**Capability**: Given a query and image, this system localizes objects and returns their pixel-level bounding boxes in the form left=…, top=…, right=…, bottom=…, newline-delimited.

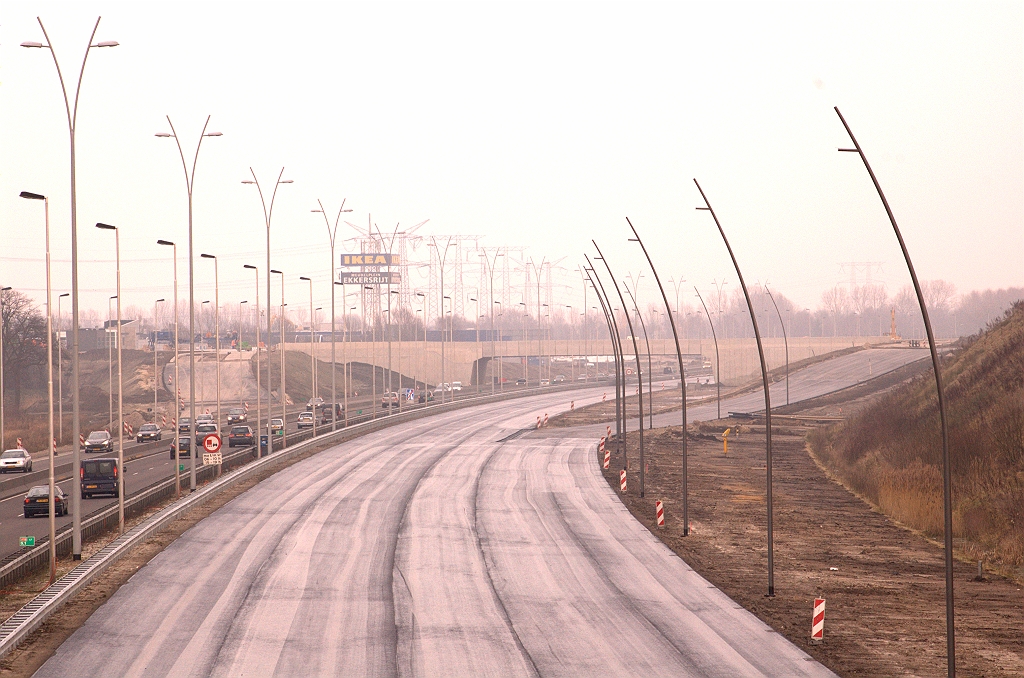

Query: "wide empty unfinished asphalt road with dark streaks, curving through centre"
left=36, top=389, right=833, bottom=676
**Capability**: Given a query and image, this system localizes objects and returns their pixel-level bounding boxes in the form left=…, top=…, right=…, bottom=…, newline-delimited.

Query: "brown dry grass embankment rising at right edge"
left=809, top=301, right=1024, bottom=581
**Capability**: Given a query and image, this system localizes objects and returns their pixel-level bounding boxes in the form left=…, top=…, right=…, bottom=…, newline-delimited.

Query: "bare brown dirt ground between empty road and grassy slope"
left=604, top=421, right=1024, bottom=676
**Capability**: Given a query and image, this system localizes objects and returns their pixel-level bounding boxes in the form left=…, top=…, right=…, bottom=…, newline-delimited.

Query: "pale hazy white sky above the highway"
left=0, top=1, right=1024, bottom=323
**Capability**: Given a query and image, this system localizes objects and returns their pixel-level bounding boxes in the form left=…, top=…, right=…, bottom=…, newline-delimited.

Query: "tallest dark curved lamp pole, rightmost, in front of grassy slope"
left=836, top=108, right=956, bottom=678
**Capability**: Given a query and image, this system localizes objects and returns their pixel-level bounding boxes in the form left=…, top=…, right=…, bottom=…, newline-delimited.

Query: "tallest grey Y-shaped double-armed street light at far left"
left=21, top=16, right=118, bottom=560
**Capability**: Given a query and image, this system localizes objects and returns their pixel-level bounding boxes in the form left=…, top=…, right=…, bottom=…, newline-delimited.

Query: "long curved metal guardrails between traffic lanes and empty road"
left=0, top=384, right=593, bottom=658
